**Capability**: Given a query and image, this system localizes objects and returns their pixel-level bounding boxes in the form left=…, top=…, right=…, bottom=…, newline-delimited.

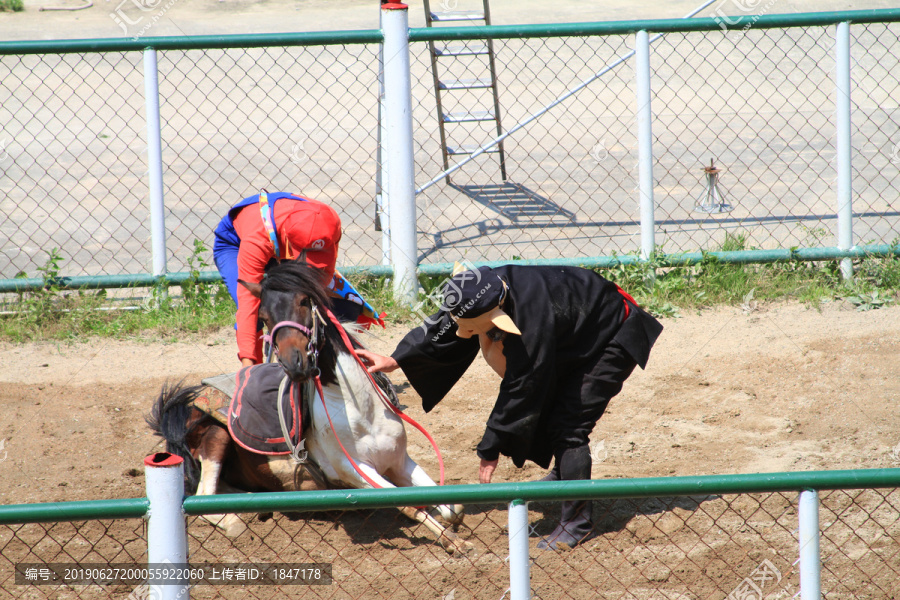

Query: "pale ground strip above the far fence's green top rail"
left=0, top=0, right=895, bottom=40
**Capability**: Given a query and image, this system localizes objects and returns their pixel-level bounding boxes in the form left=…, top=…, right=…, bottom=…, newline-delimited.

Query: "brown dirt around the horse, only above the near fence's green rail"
left=0, top=301, right=900, bottom=504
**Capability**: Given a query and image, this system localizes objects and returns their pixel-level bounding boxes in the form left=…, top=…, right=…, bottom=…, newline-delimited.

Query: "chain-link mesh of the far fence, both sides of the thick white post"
left=0, top=11, right=900, bottom=290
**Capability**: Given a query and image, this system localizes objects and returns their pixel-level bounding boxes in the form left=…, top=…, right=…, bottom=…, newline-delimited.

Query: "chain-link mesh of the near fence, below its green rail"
left=0, top=489, right=900, bottom=600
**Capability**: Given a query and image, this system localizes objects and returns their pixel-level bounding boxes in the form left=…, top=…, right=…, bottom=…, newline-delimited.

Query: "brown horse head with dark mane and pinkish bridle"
left=240, top=261, right=334, bottom=382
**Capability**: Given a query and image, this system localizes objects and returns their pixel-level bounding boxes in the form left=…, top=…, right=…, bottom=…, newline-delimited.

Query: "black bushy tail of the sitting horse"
left=145, top=381, right=204, bottom=495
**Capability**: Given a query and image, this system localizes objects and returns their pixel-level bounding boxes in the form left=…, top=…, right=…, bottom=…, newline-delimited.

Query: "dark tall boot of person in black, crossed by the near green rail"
left=538, top=446, right=594, bottom=550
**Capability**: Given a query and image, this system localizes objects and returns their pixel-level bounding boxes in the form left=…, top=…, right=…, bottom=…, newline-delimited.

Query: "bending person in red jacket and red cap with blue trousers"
left=213, top=190, right=384, bottom=366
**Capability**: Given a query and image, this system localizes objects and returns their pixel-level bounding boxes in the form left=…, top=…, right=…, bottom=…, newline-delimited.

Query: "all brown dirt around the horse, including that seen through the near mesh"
left=0, top=301, right=900, bottom=600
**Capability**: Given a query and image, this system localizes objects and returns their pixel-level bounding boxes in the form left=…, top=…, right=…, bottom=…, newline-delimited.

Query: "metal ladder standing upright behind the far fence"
left=424, top=0, right=506, bottom=184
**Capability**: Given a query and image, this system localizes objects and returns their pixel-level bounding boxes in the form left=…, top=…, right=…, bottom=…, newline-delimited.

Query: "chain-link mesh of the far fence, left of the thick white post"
left=0, top=45, right=380, bottom=278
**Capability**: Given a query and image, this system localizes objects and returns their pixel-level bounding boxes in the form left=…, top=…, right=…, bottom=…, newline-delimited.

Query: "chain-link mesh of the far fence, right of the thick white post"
left=414, top=19, right=900, bottom=261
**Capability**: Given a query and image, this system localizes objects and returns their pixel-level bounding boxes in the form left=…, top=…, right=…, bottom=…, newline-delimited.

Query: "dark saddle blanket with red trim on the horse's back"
left=200, top=363, right=309, bottom=456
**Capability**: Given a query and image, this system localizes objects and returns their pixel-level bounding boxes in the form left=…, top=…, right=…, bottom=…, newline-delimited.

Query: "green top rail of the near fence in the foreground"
left=0, top=469, right=900, bottom=525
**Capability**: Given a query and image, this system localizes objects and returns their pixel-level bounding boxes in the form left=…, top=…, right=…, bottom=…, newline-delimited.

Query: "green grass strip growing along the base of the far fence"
left=0, top=233, right=900, bottom=342
